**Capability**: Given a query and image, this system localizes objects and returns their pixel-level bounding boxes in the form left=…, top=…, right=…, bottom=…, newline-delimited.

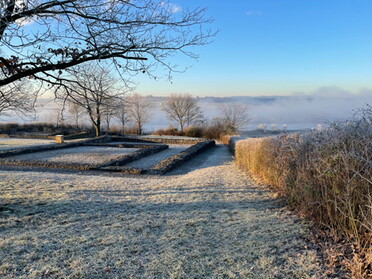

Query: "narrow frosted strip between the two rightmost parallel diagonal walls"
left=125, top=144, right=192, bottom=169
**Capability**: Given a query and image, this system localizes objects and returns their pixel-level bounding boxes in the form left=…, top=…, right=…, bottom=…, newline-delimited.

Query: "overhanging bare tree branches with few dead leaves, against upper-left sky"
left=0, top=0, right=214, bottom=91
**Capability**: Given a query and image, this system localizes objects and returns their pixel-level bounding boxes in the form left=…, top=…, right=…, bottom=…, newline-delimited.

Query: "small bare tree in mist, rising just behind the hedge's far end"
left=220, top=103, right=250, bottom=134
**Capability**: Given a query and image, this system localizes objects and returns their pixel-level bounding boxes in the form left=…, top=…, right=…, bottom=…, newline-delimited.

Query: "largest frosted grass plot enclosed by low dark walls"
left=7, top=146, right=138, bottom=164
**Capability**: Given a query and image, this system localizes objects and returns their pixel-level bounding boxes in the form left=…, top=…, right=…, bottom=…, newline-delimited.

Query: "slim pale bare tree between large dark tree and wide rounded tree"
left=128, top=93, right=151, bottom=134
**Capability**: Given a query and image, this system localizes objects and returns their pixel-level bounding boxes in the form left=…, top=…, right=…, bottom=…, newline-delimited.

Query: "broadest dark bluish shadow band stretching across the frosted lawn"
left=0, top=198, right=284, bottom=224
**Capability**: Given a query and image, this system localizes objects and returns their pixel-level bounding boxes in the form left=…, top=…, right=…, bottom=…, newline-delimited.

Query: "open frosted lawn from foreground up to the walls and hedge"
left=0, top=146, right=332, bottom=278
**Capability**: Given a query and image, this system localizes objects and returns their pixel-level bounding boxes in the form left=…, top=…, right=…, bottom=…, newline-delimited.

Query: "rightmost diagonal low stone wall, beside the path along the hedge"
left=149, top=140, right=216, bottom=174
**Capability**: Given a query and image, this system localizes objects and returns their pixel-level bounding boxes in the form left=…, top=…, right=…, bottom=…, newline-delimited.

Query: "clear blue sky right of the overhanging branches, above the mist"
left=135, top=0, right=372, bottom=96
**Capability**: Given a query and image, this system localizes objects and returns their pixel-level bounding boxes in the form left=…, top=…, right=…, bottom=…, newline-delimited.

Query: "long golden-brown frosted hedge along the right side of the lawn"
left=235, top=106, right=372, bottom=278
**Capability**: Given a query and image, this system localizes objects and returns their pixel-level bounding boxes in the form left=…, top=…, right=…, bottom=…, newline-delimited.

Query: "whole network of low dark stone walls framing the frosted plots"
left=0, top=136, right=215, bottom=175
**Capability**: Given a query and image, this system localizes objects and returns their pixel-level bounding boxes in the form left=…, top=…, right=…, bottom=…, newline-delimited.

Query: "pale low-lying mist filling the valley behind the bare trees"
left=0, top=87, right=372, bottom=131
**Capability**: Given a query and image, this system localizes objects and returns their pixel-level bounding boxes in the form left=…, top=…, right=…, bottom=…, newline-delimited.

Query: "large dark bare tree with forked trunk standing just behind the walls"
left=64, top=64, right=123, bottom=137
